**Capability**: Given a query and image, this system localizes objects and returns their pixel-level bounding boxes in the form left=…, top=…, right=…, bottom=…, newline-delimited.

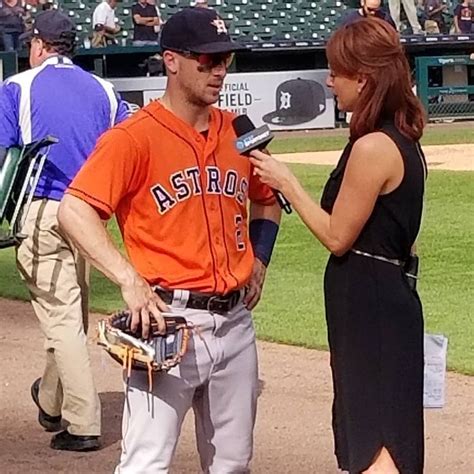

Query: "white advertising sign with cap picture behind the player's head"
left=110, top=70, right=335, bottom=130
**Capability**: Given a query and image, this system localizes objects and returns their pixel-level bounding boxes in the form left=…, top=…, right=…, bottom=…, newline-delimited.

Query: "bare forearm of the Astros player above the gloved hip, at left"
left=58, top=194, right=137, bottom=286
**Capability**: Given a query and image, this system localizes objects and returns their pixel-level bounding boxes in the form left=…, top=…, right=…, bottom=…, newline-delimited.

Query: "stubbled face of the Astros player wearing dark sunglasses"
left=177, top=53, right=233, bottom=106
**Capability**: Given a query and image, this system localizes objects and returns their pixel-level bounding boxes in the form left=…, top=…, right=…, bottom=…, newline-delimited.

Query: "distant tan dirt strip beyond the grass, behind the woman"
left=275, top=145, right=474, bottom=171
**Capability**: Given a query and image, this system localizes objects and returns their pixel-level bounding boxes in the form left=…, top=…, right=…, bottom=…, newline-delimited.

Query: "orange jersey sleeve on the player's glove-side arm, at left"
left=66, top=128, right=146, bottom=219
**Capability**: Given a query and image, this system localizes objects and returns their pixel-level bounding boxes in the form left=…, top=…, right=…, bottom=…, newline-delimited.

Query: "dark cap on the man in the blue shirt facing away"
left=20, top=10, right=76, bottom=41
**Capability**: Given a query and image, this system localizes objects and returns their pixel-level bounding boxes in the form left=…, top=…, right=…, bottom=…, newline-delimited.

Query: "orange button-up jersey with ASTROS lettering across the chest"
left=67, top=102, right=275, bottom=294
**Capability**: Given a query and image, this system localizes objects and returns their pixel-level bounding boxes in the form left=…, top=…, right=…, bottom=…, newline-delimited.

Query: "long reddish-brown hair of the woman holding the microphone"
left=326, top=18, right=425, bottom=140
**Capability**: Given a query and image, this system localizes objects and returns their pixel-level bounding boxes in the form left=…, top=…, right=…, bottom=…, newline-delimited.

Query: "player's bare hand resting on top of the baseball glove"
left=120, top=275, right=169, bottom=339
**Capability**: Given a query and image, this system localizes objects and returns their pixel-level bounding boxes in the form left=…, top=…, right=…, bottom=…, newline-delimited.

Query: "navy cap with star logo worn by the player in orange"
left=160, top=8, right=247, bottom=54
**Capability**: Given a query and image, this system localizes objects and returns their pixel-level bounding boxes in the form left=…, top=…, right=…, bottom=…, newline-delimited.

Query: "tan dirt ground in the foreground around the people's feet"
left=0, top=299, right=474, bottom=474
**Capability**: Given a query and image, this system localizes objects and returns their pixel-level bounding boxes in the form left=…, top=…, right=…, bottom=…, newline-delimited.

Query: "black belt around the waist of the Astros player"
left=154, top=288, right=243, bottom=314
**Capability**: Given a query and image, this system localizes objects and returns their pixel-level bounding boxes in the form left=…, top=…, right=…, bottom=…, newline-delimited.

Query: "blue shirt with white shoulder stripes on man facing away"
left=0, top=51, right=128, bottom=201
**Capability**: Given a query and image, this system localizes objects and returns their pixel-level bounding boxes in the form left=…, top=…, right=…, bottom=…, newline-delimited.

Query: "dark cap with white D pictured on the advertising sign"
left=262, top=78, right=326, bottom=125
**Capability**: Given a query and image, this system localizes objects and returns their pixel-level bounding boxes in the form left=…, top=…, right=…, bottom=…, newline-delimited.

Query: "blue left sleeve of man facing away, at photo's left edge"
left=0, top=82, right=22, bottom=148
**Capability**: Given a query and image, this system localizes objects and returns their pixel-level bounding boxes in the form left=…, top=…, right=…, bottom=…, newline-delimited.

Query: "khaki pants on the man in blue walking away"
left=17, top=199, right=100, bottom=436
